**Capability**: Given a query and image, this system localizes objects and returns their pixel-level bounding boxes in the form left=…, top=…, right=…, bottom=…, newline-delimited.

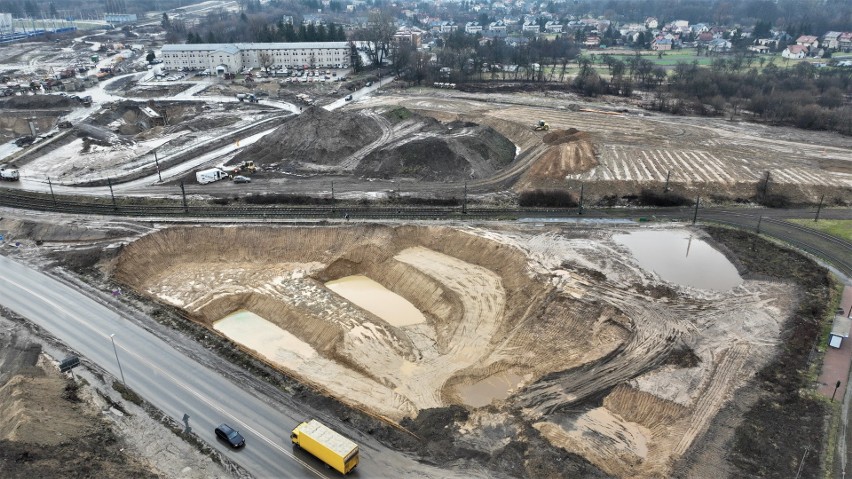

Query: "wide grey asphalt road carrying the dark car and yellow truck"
left=0, top=256, right=470, bottom=478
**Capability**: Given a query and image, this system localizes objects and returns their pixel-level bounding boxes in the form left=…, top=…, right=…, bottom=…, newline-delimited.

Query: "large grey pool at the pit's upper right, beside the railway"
left=613, top=230, right=743, bottom=291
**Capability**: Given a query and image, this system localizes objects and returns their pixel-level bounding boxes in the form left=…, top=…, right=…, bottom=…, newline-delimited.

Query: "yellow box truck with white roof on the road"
left=290, top=419, right=358, bottom=474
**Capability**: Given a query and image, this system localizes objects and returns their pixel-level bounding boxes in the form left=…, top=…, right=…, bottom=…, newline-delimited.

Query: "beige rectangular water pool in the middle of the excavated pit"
left=325, top=274, right=426, bottom=326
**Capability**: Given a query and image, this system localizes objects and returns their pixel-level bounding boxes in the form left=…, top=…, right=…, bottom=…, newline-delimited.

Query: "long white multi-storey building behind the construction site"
left=161, top=42, right=351, bottom=73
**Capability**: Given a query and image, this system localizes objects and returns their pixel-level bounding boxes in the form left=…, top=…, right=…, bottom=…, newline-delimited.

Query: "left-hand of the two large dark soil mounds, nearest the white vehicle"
left=235, top=107, right=381, bottom=170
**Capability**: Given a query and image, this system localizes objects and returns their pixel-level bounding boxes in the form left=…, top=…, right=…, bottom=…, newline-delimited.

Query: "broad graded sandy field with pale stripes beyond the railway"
left=359, top=89, right=852, bottom=202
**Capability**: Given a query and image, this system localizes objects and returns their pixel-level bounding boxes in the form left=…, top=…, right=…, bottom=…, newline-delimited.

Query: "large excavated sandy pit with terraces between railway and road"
left=113, top=225, right=793, bottom=477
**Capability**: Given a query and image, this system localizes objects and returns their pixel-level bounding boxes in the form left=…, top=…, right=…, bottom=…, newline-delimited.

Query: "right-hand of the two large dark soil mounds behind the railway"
left=355, top=119, right=515, bottom=181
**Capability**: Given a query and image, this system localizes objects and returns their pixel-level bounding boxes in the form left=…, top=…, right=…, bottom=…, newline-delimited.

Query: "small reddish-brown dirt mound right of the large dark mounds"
left=515, top=128, right=598, bottom=190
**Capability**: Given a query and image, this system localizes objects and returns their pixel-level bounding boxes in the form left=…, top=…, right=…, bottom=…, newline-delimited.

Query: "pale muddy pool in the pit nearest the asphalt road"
left=213, top=311, right=317, bottom=364
